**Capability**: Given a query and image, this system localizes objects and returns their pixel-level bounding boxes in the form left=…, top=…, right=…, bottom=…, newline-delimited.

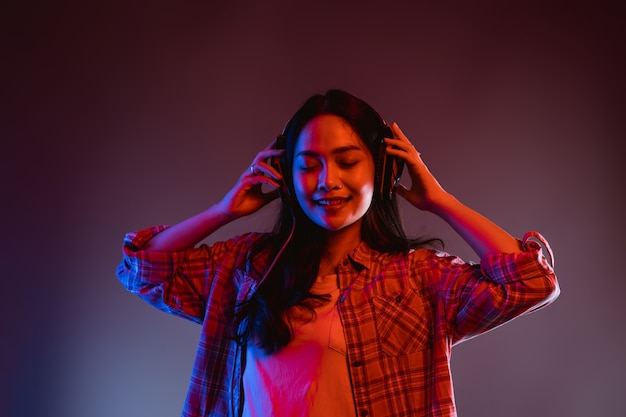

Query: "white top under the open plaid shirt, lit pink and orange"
left=243, top=275, right=356, bottom=417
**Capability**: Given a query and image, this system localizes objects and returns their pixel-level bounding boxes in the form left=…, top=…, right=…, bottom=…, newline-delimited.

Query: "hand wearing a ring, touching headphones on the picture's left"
left=217, top=143, right=285, bottom=220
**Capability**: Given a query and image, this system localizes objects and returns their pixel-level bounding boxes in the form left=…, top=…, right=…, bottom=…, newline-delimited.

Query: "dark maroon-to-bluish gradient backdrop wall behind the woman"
left=0, top=1, right=626, bottom=417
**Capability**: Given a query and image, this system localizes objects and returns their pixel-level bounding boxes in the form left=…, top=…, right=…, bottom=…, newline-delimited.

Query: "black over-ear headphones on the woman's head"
left=272, top=118, right=404, bottom=203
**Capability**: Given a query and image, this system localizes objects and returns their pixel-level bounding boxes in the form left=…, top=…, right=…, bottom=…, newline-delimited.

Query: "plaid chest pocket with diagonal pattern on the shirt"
left=373, top=288, right=432, bottom=356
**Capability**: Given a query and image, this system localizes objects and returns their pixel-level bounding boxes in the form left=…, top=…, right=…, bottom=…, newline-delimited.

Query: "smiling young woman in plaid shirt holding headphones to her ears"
left=117, top=90, right=559, bottom=417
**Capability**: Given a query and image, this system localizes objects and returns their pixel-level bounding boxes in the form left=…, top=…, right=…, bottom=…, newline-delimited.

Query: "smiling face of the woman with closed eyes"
left=293, top=114, right=375, bottom=231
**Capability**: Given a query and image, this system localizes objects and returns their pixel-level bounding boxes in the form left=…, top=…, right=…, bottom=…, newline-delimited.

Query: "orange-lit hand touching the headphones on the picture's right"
left=385, top=123, right=449, bottom=211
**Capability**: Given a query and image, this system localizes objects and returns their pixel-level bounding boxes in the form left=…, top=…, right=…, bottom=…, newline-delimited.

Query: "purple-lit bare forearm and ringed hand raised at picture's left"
left=143, top=145, right=283, bottom=252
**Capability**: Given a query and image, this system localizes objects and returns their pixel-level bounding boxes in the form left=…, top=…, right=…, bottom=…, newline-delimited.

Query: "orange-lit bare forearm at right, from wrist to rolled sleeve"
left=430, top=193, right=522, bottom=257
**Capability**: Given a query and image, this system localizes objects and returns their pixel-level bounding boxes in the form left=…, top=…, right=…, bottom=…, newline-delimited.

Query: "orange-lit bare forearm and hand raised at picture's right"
left=386, top=123, right=522, bottom=257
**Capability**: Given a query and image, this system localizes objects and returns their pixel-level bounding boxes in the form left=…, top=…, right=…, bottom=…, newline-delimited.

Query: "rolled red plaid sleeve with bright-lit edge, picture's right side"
left=432, top=232, right=560, bottom=343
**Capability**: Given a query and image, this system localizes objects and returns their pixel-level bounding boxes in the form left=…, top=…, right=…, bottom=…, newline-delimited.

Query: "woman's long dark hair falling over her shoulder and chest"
left=234, top=90, right=443, bottom=354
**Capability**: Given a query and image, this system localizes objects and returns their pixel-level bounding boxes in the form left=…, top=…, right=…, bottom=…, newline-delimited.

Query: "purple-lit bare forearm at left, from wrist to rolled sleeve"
left=143, top=205, right=234, bottom=252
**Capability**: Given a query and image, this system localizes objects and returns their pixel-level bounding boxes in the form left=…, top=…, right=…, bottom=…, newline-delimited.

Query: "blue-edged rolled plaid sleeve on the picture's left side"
left=116, top=226, right=256, bottom=323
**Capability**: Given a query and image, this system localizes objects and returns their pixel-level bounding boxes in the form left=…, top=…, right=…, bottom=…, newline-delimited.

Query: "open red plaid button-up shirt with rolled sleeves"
left=117, top=226, right=559, bottom=417
